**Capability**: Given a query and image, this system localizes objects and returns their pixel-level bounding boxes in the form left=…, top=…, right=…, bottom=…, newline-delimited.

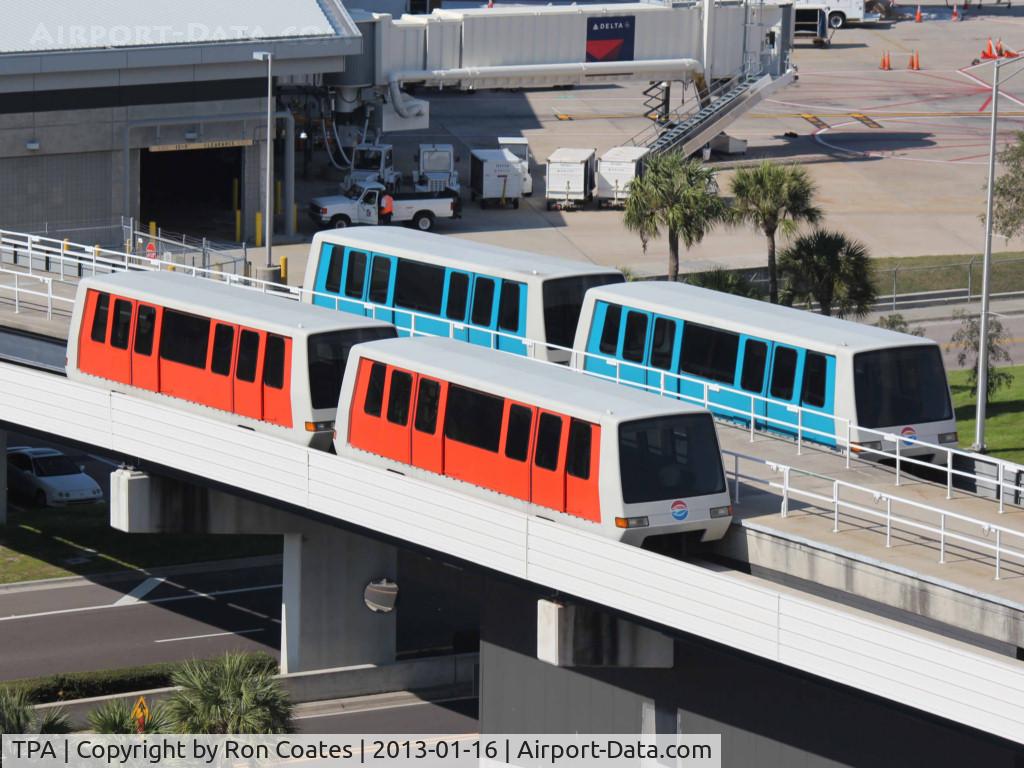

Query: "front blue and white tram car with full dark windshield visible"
left=572, top=282, right=957, bottom=460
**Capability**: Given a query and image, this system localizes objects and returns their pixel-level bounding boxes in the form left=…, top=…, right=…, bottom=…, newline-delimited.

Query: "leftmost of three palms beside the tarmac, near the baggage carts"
left=625, top=153, right=728, bottom=281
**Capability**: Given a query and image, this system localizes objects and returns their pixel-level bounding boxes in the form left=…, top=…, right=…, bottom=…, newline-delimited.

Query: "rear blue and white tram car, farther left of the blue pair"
left=303, top=226, right=624, bottom=362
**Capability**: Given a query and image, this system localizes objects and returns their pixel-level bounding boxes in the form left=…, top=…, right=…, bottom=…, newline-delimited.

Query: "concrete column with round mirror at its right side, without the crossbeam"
left=281, top=526, right=400, bottom=673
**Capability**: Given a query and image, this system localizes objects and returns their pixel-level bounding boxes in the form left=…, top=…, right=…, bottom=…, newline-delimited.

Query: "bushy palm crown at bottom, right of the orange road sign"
left=166, top=653, right=292, bottom=733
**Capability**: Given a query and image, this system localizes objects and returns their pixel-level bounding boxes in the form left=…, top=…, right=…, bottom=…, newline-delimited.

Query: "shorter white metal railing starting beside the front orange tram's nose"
left=722, top=450, right=1024, bottom=581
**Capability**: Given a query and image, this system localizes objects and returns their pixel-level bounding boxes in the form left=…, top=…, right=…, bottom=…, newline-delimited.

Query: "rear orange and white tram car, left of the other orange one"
left=68, top=271, right=395, bottom=450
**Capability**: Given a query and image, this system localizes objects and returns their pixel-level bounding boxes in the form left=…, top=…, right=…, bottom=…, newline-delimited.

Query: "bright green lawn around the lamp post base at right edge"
left=949, top=366, right=1024, bottom=464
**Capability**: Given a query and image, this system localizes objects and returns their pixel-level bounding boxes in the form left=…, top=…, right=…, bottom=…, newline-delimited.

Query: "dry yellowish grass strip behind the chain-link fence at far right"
left=871, top=252, right=1024, bottom=296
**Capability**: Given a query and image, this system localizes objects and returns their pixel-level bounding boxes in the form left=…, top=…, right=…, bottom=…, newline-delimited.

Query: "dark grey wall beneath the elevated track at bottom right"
left=480, top=579, right=1021, bottom=768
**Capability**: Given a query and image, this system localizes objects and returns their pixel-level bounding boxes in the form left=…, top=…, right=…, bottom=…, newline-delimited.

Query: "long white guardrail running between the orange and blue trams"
left=0, top=229, right=1024, bottom=513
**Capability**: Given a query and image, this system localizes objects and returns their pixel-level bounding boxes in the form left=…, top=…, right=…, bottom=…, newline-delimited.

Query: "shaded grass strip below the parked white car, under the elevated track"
left=0, top=504, right=281, bottom=584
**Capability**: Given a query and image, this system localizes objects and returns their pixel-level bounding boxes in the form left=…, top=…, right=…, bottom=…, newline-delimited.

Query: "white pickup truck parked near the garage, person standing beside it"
left=309, top=182, right=462, bottom=232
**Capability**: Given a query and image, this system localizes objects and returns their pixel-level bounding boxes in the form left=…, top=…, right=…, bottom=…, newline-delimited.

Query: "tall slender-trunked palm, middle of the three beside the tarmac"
left=732, top=160, right=821, bottom=304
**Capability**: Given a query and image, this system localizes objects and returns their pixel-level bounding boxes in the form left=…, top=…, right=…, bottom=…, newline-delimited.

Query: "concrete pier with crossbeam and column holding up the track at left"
left=111, top=469, right=398, bottom=673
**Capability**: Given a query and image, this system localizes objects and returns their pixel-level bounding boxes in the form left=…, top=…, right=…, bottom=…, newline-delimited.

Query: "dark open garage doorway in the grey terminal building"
left=139, top=146, right=244, bottom=241
